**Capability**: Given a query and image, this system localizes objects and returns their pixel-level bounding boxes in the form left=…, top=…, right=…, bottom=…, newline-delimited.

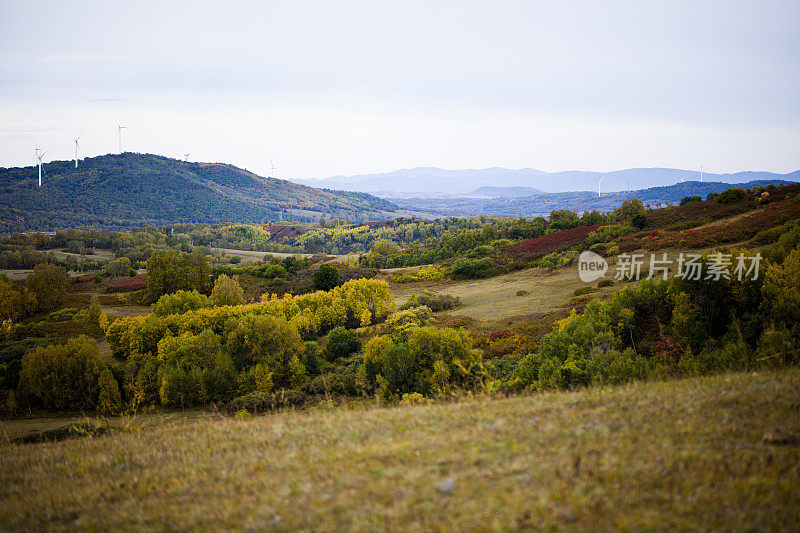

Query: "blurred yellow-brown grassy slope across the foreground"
left=0, top=370, right=800, bottom=531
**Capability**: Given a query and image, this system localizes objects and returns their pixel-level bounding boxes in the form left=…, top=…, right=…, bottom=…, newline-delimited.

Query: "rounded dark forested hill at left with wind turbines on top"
left=0, top=153, right=396, bottom=232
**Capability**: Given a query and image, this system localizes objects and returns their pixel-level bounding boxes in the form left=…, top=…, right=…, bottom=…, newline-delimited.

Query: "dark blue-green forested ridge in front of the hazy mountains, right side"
left=395, top=180, right=792, bottom=217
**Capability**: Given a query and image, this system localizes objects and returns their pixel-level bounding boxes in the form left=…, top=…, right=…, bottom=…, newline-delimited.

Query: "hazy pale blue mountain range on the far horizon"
left=294, top=167, right=800, bottom=198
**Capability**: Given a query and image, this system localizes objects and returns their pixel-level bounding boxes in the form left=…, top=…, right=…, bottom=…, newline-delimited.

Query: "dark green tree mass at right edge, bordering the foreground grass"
left=506, top=230, right=800, bottom=390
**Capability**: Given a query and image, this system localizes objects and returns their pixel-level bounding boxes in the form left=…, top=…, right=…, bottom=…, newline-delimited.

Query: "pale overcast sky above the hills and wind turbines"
left=0, top=0, right=800, bottom=178
